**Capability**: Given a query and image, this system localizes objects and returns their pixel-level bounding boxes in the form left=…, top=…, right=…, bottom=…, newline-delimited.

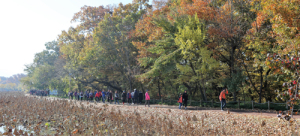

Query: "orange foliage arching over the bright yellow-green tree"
left=133, top=0, right=250, bottom=63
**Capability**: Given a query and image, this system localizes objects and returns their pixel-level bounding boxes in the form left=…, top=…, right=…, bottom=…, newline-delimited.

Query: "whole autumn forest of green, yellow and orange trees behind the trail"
left=21, top=0, right=300, bottom=102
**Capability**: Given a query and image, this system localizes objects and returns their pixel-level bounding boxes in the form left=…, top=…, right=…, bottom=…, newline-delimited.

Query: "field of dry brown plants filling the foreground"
left=0, top=93, right=299, bottom=136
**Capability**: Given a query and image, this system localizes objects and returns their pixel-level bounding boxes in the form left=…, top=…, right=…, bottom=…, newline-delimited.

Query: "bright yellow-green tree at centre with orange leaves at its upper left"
left=134, top=0, right=218, bottom=100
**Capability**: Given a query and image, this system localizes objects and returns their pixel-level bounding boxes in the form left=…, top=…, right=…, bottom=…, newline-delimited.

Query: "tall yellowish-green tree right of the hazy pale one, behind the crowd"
left=68, top=1, right=149, bottom=91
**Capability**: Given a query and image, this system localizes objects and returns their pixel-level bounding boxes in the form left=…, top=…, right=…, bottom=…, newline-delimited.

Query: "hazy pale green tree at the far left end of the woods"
left=21, top=41, right=66, bottom=91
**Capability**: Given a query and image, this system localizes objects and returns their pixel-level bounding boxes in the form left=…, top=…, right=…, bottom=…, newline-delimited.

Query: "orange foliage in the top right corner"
left=262, top=0, right=300, bottom=53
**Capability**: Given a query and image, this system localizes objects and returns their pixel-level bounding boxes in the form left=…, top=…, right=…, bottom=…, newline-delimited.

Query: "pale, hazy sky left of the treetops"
left=0, top=0, right=136, bottom=77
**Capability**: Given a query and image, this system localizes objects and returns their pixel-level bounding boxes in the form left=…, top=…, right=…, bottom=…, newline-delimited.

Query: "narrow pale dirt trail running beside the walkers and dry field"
left=26, top=94, right=300, bottom=119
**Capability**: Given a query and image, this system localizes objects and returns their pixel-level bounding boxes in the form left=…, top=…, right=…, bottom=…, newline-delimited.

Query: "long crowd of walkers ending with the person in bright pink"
left=68, top=89, right=150, bottom=107
